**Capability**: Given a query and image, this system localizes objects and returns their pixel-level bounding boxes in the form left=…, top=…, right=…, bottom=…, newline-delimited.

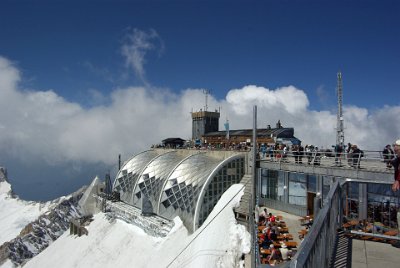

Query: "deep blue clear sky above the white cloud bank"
left=0, top=1, right=400, bottom=109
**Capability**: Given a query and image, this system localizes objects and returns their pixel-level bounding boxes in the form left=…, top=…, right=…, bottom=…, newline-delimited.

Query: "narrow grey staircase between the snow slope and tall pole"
left=234, top=174, right=253, bottom=226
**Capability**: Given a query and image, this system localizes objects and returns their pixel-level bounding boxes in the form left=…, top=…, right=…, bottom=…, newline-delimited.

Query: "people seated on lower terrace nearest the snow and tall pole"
left=258, top=208, right=290, bottom=265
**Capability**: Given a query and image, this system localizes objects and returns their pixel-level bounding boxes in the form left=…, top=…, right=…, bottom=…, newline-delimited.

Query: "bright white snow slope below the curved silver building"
left=24, top=184, right=250, bottom=268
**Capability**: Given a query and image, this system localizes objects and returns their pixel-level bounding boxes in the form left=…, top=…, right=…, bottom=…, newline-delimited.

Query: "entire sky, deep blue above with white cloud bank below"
left=0, top=0, right=400, bottom=199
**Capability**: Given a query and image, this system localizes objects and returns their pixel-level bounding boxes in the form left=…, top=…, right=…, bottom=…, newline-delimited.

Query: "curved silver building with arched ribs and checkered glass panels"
left=113, top=150, right=245, bottom=232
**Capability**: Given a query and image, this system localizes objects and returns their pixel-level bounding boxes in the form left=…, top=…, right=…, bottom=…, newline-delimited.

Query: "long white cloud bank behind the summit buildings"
left=0, top=56, right=400, bottom=200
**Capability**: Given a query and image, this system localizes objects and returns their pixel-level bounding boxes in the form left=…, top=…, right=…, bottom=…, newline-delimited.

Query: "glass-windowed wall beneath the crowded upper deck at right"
left=259, top=168, right=400, bottom=230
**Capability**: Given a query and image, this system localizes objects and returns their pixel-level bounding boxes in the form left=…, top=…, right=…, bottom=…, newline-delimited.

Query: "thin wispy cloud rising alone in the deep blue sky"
left=121, top=29, right=164, bottom=85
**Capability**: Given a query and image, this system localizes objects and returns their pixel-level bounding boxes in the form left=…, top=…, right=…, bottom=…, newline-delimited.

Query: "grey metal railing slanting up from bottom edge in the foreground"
left=290, top=181, right=343, bottom=268
